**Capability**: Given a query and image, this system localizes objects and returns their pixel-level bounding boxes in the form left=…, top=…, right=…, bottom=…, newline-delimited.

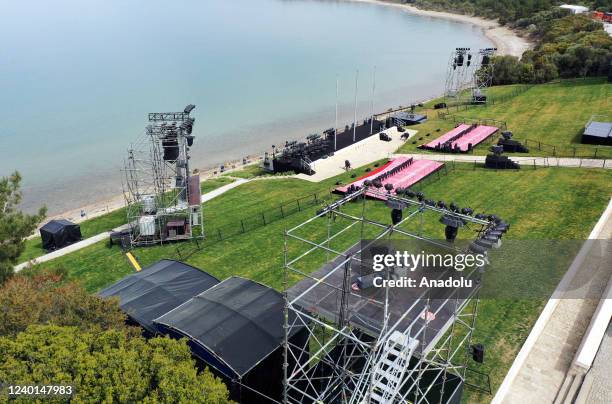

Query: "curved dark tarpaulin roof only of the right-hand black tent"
left=155, top=277, right=296, bottom=377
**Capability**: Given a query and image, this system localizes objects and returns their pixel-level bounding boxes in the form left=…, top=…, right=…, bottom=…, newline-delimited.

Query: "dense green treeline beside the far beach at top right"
left=412, top=0, right=612, bottom=84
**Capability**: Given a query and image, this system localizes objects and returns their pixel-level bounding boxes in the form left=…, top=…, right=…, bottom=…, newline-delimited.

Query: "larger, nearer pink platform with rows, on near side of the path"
left=336, top=157, right=444, bottom=200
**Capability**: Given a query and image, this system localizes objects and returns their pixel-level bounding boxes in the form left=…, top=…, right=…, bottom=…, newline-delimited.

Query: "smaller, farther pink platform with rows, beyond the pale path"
left=420, top=123, right=499, bottom=153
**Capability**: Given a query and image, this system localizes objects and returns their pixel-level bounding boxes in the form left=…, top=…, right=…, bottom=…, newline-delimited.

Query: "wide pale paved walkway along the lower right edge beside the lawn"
left=493, top=201, right=612, bottom=404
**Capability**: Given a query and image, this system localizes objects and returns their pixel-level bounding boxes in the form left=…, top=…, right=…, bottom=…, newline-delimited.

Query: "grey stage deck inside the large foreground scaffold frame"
left=287, top=244, right=468, bottom=355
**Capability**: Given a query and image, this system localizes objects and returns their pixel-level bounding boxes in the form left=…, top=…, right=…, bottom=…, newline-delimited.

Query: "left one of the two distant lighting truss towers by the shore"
left=444, top=48, right=475, bottom=107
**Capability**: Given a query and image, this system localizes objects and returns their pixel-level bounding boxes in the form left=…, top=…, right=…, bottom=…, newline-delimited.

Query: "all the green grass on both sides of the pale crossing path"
left=13, top=80, right=612, bottom=402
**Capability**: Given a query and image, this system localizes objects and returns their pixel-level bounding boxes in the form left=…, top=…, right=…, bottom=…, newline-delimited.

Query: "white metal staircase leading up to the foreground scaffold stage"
left=369, top=330, right=419, bottom=404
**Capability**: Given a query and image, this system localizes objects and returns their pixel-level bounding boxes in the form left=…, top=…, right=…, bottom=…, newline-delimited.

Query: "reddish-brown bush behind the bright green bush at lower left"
left=0, top=273, right=128, bottom=336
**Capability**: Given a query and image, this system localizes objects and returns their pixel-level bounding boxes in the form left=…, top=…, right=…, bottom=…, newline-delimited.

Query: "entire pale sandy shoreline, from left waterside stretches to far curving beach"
left=45, top=0, right=533, bottom=227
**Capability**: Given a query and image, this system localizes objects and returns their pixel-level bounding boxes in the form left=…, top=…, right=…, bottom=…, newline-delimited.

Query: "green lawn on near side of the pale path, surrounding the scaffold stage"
left=23, top=160, right=612, bottom=402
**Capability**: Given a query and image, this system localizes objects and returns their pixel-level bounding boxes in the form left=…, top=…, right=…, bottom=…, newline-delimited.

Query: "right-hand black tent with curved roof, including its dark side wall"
left=155, top=277, right=306, bottom=403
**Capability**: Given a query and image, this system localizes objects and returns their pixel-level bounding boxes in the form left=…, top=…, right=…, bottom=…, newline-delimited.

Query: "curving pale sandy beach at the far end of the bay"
left=350, top=0, right=533, bottom=57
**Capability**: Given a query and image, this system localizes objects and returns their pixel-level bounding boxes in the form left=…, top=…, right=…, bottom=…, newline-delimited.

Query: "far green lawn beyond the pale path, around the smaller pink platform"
left=400, top=78, right=612, bottom=158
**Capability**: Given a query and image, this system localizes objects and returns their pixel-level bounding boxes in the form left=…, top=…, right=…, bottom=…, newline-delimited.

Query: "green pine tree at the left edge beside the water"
left=0, top=172, right=46, bottom=284
